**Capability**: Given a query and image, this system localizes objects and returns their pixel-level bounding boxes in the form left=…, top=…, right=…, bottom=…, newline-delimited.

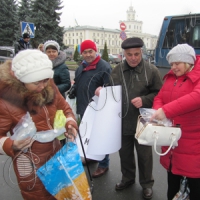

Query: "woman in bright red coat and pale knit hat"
left=152, top=44, right=200, bottom=200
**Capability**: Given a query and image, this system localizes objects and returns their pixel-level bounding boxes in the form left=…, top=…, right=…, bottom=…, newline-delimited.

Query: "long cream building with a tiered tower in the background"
left=63, top=6, right=157, bottom=54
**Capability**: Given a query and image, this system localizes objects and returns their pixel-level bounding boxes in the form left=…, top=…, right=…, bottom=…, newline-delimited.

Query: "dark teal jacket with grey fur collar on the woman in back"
left=52, top=51, right=71, bottom=98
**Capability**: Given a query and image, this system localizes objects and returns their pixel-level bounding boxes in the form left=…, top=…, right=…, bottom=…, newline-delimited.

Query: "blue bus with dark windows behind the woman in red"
left=154, top=13, right=200, bottom=71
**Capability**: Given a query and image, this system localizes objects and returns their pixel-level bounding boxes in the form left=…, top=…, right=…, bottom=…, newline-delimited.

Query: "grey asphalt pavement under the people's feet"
left=0, top=150, right=167, bottom=200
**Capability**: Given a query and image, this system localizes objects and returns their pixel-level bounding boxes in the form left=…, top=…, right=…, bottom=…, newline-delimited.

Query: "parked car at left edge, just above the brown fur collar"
left=0, top=46, right=15, bottom=64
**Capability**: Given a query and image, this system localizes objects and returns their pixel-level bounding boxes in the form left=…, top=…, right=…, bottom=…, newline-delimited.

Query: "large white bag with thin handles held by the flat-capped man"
left=77, top=86, right=122, bottom=159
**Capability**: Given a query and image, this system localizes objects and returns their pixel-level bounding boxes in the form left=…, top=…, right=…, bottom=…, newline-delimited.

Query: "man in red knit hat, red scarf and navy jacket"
left=69, top=40, right=112, bottom=178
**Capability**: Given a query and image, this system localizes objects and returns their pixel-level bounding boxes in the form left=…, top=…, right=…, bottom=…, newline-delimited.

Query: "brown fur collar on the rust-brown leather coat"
left=0, top=61, right=55, bottom=114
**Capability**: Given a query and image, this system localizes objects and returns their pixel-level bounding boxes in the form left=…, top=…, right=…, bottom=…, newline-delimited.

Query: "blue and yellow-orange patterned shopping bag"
left=37, top=142, right=92, bottom=200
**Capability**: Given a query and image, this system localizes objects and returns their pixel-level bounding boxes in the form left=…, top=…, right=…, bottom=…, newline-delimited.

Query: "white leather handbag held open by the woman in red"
left=135, top=115, right=181, bottom=156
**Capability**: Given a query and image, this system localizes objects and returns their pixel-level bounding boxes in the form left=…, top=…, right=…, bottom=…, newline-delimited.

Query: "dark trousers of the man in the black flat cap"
left=119, top=135, right=154, bottom=188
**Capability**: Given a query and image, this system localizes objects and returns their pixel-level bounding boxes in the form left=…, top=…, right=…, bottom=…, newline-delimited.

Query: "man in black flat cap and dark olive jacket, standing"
left=98, top=37, right=162, bottom=199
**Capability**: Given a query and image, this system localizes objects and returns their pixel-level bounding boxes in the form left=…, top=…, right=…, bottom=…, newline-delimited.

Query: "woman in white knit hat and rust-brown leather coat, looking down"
left=0, top=50, right=78, bottom=200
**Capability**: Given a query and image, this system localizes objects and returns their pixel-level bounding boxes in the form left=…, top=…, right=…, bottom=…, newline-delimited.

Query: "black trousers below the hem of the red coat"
left=167, top=172, right=200, bottom=200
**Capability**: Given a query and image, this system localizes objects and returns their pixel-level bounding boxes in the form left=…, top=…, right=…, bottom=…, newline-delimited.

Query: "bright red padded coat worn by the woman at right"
left=153, top=56, right=200, bottom=178
